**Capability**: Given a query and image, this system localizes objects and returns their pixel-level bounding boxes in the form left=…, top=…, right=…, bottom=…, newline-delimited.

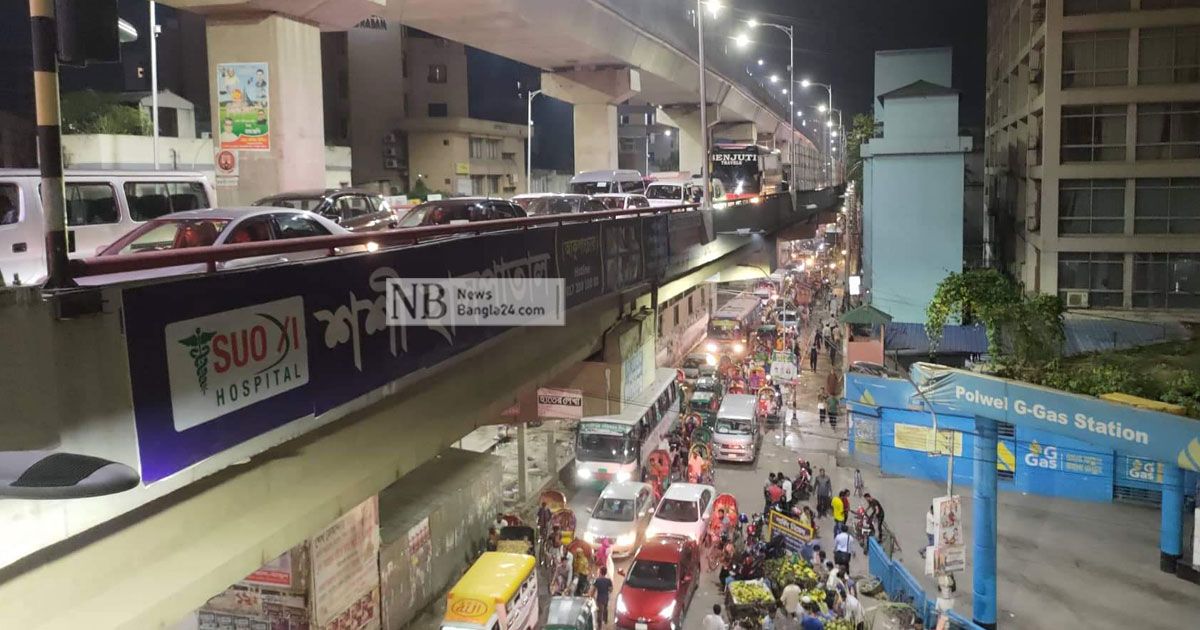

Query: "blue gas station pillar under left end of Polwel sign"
left=972, top=416, right=997, bottom=629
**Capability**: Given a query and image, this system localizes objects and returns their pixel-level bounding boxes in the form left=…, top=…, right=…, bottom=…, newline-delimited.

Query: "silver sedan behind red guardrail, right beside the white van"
left=76, top=206, right=355, bottom=284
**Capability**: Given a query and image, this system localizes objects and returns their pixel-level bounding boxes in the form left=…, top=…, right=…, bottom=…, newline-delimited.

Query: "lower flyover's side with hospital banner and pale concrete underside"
left=0, top=190, right=836, bottom=629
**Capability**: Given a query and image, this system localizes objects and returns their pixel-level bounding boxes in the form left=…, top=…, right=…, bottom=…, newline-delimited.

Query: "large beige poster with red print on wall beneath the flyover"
left=311, top=496, right=379, bottom=630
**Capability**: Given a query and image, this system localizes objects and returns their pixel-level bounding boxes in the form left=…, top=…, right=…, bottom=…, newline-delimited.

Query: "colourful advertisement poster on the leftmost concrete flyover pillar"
left=216, top=61, right=271, bottom=151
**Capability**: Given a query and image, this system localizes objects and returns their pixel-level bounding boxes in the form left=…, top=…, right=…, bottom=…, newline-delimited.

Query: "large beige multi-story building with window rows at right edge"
left=985, top=0, right=1200, bottom=308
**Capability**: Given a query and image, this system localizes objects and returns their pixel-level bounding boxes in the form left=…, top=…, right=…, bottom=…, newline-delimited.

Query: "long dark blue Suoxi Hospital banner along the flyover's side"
left=121, top=215, right=710, bottom=484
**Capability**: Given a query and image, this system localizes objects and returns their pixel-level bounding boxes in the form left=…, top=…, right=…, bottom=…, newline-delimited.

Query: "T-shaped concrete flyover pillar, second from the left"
left=534, top=68, right=642, bottom=172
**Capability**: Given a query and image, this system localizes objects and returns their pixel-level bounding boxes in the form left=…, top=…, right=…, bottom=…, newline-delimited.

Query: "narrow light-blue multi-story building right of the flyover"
left=860, top=48, right=972, bottom=323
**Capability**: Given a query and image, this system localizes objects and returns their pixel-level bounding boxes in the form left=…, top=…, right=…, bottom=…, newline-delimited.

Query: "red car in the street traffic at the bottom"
left=616, top=535, right=700, bottom=630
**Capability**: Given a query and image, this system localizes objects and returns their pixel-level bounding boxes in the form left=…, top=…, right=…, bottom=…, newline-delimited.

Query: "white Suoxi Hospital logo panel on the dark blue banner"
left=166, top=298, right=308, bottom=431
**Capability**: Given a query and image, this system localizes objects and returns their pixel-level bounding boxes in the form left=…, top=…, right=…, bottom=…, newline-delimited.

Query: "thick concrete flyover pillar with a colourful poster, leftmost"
left=208, top=14, right=325, bottom=205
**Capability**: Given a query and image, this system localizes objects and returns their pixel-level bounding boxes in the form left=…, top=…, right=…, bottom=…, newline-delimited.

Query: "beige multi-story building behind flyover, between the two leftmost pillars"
left=322, top=18, right=526, bottom=196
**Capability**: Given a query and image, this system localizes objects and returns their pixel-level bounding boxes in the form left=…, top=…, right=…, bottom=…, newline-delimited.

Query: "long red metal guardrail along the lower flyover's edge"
left=70, top=204, right=697, bottom=277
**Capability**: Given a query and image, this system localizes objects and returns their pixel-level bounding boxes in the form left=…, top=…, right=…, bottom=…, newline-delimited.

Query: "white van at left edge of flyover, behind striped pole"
left=0, top=168, right=216, bottom=284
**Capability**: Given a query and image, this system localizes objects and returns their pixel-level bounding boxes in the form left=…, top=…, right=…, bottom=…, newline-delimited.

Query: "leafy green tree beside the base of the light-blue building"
left=925, top=269, right=1063, bottom=365
